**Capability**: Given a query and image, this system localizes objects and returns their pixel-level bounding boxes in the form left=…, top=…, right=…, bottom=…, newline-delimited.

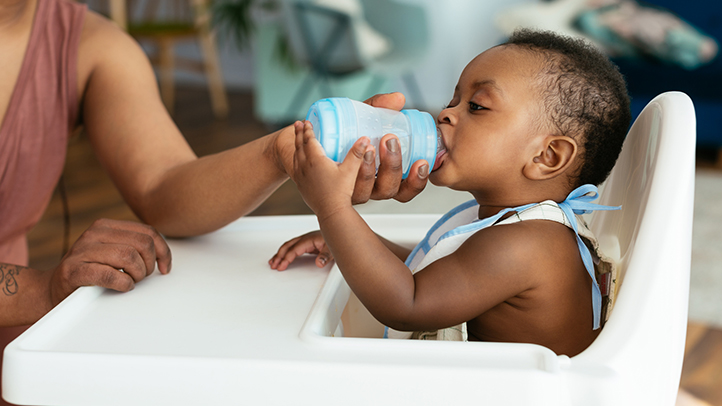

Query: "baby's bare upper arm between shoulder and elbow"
left=396, top=222, right=568, bottom=331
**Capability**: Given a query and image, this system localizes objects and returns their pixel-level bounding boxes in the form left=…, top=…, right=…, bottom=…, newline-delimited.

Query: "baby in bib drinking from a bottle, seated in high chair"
left=269, top=30, right=631, bottom=356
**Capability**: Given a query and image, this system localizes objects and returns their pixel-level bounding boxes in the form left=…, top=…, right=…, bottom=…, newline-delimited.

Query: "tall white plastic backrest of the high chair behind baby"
left=570, top=92, right=696, bottom=405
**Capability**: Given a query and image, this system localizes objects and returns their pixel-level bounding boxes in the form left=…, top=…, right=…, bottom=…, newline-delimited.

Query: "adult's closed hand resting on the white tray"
left=50, top=219, right=171, bottom=306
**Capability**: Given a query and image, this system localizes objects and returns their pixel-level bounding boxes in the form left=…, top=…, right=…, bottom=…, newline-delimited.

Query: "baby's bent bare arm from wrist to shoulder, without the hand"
left=320, top=206, right=549, bottom=330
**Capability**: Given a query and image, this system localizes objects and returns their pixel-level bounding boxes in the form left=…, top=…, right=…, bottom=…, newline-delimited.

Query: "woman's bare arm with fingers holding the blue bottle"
left=79, top=13, right=428, bottom=236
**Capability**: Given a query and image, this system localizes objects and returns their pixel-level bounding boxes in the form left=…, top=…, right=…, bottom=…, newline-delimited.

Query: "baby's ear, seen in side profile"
left=523, top=135, right=577, bottom=180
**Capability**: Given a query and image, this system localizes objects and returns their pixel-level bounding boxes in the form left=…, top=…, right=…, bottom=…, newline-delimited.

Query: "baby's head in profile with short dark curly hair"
left=430, top=30, right=631, bottom=200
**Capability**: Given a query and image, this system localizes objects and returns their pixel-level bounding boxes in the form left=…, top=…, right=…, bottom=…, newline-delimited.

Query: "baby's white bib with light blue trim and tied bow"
left=384, top=185, right=620, bottom=341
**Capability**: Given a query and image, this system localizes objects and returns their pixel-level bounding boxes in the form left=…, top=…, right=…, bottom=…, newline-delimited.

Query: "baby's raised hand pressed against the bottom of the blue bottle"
left=293, top=121, right=374, bottom=218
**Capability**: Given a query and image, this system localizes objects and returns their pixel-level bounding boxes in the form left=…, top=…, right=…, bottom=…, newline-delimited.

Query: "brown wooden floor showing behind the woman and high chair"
left=29, top=89, right=722, bottom=406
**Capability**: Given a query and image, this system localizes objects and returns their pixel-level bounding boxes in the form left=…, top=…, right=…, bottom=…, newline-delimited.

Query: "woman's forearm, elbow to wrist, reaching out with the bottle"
left=134, top=126, right=293, bottom=237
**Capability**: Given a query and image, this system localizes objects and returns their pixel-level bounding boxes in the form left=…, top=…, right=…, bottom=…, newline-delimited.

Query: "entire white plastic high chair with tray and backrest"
left=3, top=93, right=695, bottom=406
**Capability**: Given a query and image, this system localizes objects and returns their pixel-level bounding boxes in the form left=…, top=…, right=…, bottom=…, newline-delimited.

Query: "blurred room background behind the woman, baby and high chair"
left=29, top=0, right=722, bottom=405
